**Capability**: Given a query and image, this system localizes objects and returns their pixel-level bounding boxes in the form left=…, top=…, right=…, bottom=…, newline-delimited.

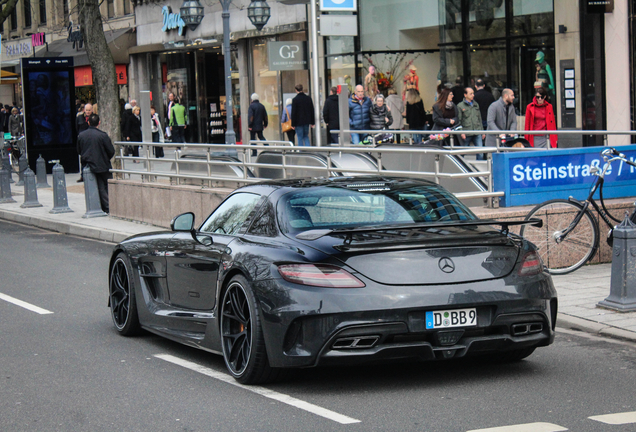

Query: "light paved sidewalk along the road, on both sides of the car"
left=0, top=170, right=636, bottom=342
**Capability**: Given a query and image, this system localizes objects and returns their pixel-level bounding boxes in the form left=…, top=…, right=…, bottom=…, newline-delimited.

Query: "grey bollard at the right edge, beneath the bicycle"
left=598, top=214, right=636, bottom=312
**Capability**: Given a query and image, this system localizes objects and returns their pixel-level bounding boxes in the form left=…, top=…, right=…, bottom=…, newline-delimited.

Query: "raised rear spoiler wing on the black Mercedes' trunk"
left=296, top=219, right=543, bottom=243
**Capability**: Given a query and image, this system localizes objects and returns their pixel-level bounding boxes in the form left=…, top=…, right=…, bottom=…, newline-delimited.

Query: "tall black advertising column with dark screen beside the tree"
left=21, top=57, right=79, bottom=173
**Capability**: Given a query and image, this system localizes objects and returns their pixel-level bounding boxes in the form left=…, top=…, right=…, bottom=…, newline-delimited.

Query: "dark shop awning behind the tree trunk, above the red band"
left=38, top=28, right=137, bottom=66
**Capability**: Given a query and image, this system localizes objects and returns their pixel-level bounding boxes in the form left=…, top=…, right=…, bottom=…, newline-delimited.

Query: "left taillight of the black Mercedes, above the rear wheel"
left=278, top=264, right=365, bottom=288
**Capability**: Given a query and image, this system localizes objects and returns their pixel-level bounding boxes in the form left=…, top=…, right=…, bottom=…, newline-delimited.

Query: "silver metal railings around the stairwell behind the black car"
left=112, top=130, right=635, bottom=206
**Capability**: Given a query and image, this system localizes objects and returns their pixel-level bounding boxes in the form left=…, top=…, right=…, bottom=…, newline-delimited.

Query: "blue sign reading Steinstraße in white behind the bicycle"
left=493, top=145, right=636, bottom=207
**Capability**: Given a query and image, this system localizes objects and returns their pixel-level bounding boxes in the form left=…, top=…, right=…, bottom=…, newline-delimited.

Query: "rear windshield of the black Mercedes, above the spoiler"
left=277, top=181, right=477, bottom=232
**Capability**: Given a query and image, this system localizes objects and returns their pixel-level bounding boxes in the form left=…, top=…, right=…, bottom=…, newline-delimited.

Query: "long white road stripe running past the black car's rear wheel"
left=153, top=354, right=360, bottom=426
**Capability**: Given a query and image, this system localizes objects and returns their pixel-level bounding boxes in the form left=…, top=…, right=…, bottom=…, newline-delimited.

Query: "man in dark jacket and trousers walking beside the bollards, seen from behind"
left=77, top=114, right=115, bottom=213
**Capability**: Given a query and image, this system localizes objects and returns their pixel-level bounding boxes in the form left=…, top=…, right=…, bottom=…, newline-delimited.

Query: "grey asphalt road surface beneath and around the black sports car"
left=0, top=222, right=636, bottom=432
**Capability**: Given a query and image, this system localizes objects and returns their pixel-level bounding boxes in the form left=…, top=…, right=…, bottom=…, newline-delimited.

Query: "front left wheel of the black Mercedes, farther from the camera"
left=108, top=252, right=141, bottom=336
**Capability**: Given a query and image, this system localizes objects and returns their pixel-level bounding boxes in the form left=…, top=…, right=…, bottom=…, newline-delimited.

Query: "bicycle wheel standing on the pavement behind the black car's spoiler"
left=521, top=199, right=599, bottom=274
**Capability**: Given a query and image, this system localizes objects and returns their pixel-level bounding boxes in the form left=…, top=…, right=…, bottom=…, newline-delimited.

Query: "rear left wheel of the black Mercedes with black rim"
left=220, top=275, right=280, bottom=384
